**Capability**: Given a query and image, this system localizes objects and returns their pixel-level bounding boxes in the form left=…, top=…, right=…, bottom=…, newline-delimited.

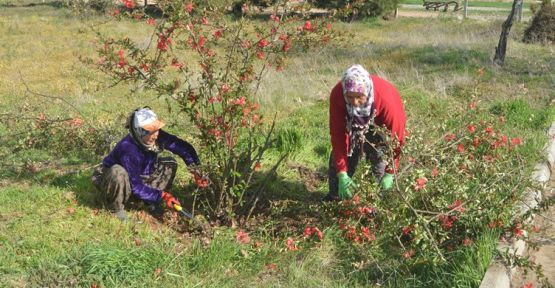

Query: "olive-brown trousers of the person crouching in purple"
left=92, top=157, right=177, bottom=212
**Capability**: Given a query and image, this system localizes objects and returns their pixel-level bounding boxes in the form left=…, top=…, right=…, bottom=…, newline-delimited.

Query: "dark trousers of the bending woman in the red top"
left=328, top=128, right=388, bottom=197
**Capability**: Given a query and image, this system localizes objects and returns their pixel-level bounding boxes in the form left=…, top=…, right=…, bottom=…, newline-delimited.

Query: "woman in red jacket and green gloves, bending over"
left=324, top=65, right=406, bottom=201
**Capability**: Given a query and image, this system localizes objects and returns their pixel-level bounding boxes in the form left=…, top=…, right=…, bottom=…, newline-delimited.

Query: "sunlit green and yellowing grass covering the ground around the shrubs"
left=0, top=1, right=555, bottom=287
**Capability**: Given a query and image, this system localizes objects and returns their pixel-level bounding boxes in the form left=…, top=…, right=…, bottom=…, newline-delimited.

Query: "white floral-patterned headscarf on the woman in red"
left=341, top=64, right=374, bottom=125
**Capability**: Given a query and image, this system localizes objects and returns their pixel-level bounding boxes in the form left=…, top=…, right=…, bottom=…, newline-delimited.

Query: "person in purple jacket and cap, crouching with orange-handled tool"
left=92, top=108, right=200, bottom=221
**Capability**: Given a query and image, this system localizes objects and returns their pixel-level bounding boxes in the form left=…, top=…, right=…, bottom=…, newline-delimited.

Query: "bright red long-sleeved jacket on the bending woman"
left=330, top=75, right=406, bottom=173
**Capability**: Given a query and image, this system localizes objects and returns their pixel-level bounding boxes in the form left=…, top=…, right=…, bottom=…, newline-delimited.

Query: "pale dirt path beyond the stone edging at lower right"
left=513, top=169, right=555, bottom=287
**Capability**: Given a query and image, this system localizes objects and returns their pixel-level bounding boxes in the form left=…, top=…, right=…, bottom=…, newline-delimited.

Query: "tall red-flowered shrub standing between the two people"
left=97, top=1, right=333, bottom=220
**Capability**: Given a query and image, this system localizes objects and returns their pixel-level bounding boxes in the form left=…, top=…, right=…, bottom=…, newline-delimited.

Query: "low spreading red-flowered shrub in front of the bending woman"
left=330, top=102, right=528, bottom=268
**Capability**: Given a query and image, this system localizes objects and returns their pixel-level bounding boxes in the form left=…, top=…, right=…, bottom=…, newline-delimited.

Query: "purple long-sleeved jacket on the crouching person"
left=102, top=130, right=199, bottom=203
